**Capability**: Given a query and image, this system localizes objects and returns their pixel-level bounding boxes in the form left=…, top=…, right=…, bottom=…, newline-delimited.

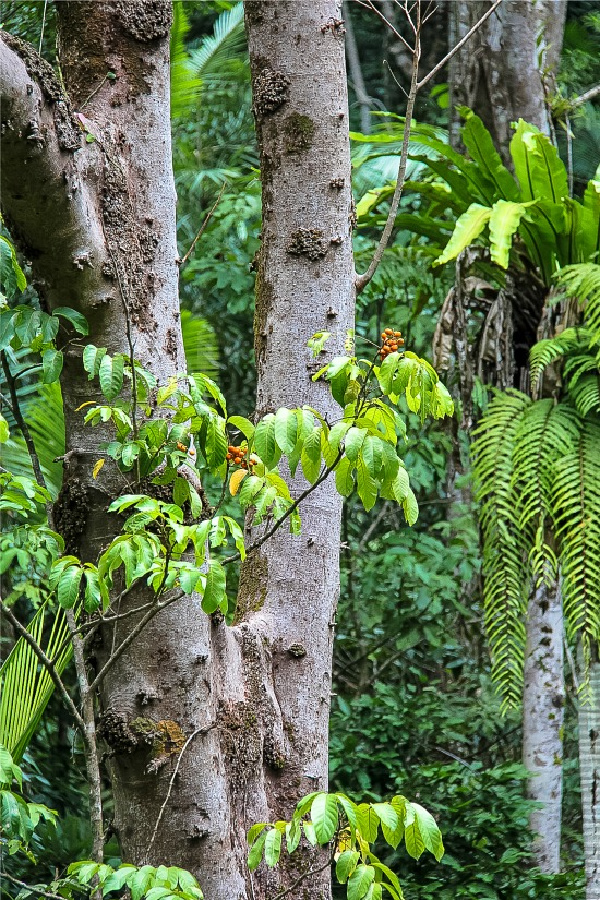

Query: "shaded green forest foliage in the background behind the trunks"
left=2, top=2, right=600, bottom=900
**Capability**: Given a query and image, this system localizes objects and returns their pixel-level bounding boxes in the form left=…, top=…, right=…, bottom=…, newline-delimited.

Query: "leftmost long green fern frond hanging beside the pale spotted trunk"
left=472, top=390, right=531, bottom=706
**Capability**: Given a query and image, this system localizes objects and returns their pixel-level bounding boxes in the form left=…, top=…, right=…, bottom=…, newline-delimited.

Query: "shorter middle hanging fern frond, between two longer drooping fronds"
left=512, top=399, right=579, bottom=580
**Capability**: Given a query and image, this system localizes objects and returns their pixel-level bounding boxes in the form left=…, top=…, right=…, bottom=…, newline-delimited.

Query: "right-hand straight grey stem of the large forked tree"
left=244, top=0, right=354, bottom=900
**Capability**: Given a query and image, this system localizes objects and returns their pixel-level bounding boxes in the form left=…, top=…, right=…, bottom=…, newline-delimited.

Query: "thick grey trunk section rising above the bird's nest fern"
left=448, top=0, right=567, bottom=165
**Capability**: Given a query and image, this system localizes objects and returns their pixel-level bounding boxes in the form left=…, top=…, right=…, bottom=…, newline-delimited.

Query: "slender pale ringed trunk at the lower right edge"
left=579, top=647, right=600, bottom=900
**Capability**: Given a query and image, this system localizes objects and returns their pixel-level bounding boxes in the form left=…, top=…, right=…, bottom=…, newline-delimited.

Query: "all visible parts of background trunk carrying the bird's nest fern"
left=441, top=0, right=566, bottom=873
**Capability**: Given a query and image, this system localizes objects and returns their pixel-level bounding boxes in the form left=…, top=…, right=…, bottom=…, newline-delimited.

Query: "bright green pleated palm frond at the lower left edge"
left=0, top=602, right=72, bottom=762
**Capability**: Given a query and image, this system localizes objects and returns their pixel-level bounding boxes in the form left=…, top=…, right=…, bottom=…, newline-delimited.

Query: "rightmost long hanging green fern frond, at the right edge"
left=553, top=420, right=600, bottom=660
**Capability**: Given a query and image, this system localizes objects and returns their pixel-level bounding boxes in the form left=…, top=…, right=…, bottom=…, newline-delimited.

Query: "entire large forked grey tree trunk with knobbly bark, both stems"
left=0, top=0, right=355, bottom=900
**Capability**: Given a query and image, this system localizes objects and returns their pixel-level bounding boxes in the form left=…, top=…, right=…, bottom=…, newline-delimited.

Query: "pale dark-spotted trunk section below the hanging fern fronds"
left=523, top=585, right=565, bottom=874
